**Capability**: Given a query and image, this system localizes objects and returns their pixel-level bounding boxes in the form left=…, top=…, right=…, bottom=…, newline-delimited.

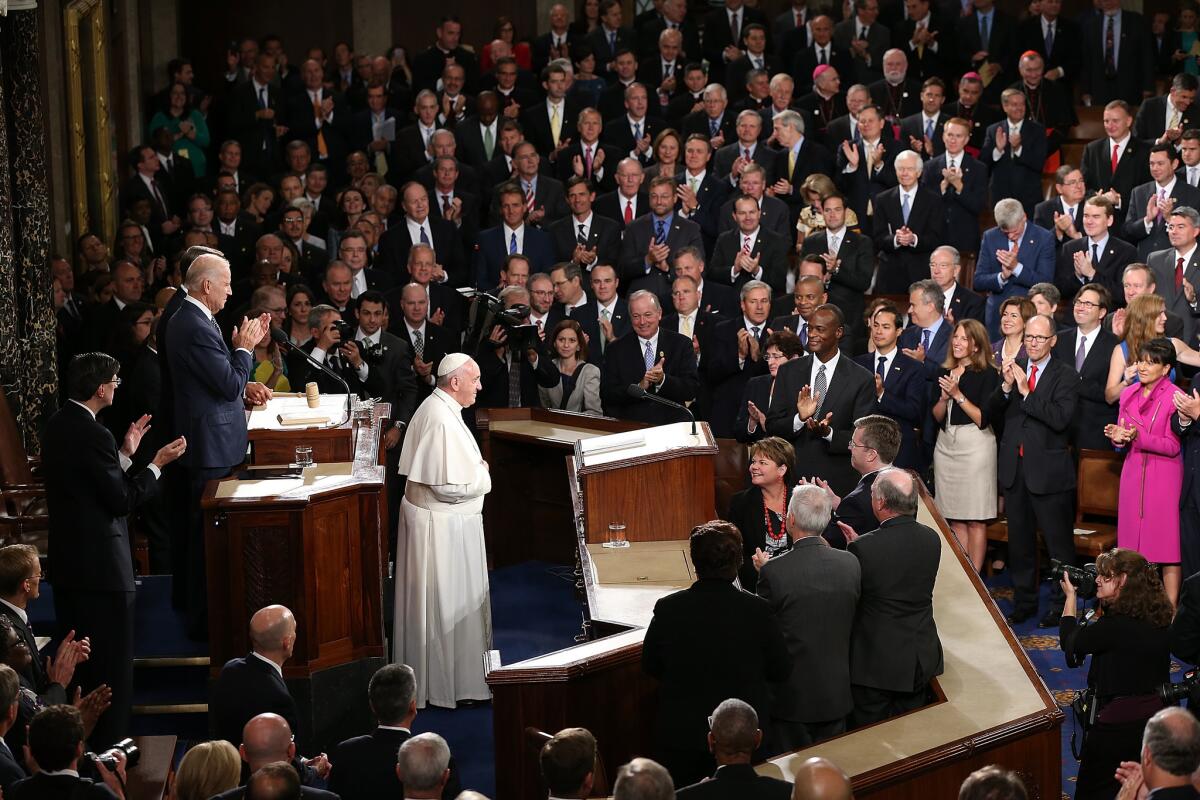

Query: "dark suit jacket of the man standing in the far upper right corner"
left=1079, top=11, right=1154, bottom=108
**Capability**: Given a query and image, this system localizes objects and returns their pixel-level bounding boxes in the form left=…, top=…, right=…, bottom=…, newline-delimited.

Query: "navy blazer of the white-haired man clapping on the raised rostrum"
left=168, top=301, right=253, bottom=469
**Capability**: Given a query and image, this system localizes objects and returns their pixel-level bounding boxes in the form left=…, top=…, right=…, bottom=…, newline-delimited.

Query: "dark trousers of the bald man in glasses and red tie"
left=1004, top=461, right=1075, bottom=613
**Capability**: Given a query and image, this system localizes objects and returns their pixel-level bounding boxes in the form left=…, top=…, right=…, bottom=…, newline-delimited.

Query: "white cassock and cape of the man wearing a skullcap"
left=392, top=389, right=492, bottom=708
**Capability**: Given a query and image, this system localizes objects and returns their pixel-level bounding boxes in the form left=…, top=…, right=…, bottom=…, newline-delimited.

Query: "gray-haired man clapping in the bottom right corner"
left=1117, top=705, right=1200, bottom=800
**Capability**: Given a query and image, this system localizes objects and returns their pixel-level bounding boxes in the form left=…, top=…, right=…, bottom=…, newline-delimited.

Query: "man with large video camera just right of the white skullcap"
left=475, top=287, right=540, bottom=408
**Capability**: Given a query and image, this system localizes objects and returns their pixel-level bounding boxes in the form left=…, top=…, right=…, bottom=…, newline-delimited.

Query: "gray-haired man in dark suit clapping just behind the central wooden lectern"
left=600, top=290, right=700, bottom=425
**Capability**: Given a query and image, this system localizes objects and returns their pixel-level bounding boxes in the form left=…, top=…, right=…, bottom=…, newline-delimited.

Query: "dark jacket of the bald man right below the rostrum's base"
left=209, top=652, right=301, bottom=746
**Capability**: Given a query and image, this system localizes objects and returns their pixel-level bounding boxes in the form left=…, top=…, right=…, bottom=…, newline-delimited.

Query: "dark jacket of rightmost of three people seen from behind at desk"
left=846, top=517, right=942, bottom=692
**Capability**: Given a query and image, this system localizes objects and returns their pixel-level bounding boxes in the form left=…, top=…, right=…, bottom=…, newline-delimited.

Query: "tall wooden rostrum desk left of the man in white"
left=202, top=404, right=388, bottom=750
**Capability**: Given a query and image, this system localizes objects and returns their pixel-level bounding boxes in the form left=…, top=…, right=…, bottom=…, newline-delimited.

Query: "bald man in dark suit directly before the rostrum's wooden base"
left=209, top=606, right=299, bottom=745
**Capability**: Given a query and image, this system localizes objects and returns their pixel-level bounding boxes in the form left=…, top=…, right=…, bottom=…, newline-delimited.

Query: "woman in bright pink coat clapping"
left=1104, top=338, right=1183, bottom=604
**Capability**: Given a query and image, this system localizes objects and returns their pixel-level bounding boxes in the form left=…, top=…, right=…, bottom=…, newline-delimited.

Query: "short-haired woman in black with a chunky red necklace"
left=726, top=437, right=796, bottom=591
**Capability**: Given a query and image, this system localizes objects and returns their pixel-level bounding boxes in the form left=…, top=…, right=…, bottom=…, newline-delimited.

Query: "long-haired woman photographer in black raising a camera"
left=1058, top=547, right=1172, bottom=800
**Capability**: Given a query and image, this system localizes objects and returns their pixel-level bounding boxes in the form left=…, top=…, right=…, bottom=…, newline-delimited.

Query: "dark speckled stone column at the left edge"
left=0, top=4, right=58, bottom=453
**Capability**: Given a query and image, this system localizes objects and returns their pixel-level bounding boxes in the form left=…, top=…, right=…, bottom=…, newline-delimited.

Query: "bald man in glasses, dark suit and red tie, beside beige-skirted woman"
left=989, top=314, right=1080, bottom=627
